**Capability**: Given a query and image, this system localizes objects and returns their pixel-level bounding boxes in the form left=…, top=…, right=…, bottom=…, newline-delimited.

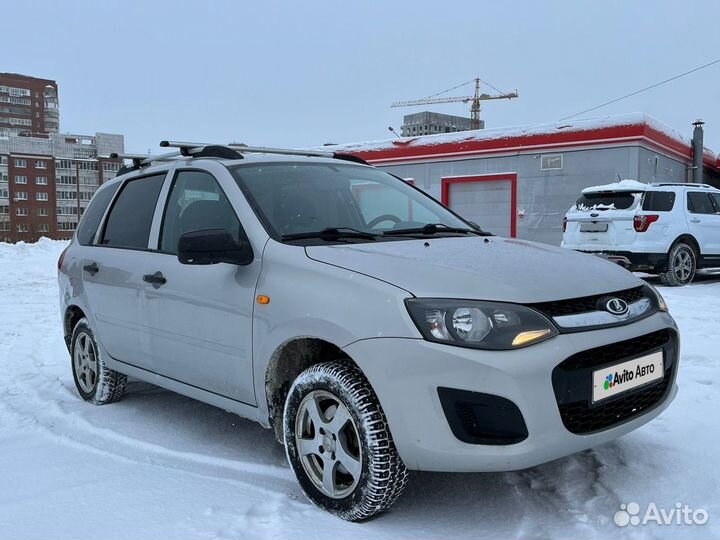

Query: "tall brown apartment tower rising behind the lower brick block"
left=0, top=73, right=60, bottom=135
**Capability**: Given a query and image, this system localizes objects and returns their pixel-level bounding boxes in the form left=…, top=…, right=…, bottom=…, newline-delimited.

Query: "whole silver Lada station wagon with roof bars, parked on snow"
left=58, top=143, right=678, bottom=520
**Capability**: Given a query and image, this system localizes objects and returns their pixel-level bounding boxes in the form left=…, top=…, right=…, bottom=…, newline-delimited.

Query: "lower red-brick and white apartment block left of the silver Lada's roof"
left=0, top=133, right=125, bottom=242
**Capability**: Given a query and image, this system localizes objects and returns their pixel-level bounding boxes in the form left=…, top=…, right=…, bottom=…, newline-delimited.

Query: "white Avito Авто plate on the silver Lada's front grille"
left=593, top=351, right=665, bottom=403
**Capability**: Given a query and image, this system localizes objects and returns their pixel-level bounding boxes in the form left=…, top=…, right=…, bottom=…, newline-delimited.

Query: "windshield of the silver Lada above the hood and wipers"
left=230, top=163, right=477, bottom=242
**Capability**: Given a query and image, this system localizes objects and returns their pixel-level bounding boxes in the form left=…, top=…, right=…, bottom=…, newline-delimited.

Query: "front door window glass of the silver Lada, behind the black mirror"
left=160, top=171, right=245, bottom=254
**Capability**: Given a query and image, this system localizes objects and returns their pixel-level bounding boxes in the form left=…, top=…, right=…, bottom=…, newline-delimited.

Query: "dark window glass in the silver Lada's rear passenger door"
left=101, top=173, right=165, bottom=249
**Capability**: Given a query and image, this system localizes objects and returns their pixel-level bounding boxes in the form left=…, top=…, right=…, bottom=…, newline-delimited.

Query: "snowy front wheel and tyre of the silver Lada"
left=283, top=361, right=408, bottom=521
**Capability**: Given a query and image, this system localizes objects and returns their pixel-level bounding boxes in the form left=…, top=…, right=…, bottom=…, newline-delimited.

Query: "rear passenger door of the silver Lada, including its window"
left=78, top=172, right=165, bottom=367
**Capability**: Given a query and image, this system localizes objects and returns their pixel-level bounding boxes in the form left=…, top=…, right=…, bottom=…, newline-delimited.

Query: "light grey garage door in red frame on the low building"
left=448, top=180, right=512, bottom=237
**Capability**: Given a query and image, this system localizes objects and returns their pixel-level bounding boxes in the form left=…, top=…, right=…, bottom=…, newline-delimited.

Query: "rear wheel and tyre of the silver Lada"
left=70, top=318, right=127, bottom=405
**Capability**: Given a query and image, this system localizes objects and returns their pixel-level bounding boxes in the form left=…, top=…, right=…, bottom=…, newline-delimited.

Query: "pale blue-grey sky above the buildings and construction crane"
left=5, top=0, right=720, bottom=152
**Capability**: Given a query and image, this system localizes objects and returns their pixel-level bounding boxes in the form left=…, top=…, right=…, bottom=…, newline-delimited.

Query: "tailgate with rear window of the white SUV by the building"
left=563, top=191, right=642, bottom=249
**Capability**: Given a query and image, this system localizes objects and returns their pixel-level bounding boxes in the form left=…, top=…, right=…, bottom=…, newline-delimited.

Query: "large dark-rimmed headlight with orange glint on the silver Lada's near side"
left=405, top=298, right=558, bottom=350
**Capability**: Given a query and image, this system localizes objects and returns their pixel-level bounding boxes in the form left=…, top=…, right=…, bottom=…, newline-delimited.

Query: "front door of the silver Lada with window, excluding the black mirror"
left=143, top=170, right=260, bottom=405
